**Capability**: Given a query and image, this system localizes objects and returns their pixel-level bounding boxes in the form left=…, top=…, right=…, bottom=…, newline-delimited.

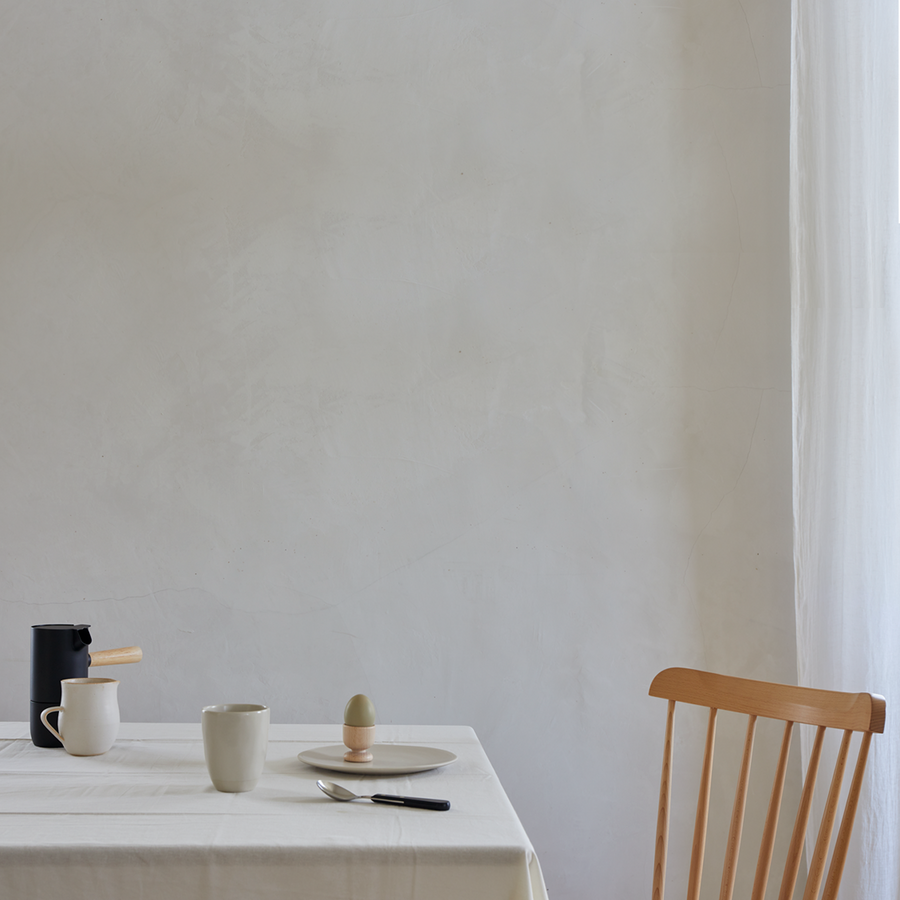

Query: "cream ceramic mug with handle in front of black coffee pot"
left=41, top=678, right=119, bottom=756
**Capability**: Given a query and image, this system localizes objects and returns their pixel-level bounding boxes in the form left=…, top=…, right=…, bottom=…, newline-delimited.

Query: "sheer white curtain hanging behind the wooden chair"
left=790, top=0, right=900, bottom=900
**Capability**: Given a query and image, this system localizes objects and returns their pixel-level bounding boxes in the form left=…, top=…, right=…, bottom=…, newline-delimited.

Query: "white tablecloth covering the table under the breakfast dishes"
left=0, top=723, right=547, bottom=900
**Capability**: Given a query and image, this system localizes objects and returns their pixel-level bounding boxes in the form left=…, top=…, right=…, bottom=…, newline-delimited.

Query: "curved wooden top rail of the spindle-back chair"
left=650, top=668, right=885, bottom=734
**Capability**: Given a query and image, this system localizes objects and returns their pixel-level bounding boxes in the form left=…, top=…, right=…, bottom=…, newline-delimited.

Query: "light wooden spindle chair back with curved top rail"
left=650, top=669, right=885, bottom=900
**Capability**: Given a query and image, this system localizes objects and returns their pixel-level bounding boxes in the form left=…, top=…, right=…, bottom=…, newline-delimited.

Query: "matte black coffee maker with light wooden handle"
left=31, top=625, right=143, bottom=747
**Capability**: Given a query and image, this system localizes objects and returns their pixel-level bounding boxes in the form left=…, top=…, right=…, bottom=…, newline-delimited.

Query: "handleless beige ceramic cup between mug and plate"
left=200, top=703, right=269, bottom=793
